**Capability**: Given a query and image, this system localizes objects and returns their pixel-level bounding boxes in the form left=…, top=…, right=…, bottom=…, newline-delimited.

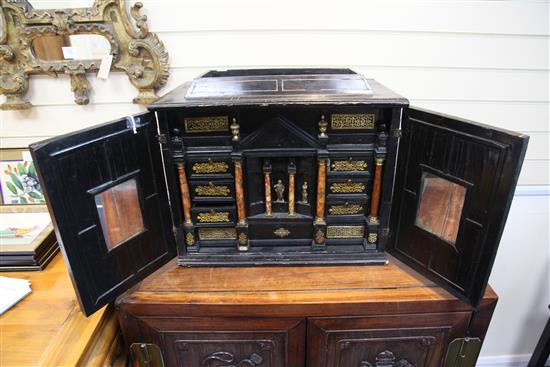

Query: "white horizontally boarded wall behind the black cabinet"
left=0, top=0, right=550, bottom=363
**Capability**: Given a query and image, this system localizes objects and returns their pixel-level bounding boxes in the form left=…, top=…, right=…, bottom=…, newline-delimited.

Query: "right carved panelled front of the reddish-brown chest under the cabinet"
left=307, top=312, right=470, bottom=367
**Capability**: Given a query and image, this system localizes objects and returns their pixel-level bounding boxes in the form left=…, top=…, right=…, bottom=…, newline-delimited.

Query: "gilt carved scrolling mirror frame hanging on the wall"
left=0, top=0, right=169, bottom=110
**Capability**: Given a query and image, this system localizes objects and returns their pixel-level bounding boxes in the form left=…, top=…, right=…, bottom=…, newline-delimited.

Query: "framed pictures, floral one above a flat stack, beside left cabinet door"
left=0, top=149, right=59, bottom=271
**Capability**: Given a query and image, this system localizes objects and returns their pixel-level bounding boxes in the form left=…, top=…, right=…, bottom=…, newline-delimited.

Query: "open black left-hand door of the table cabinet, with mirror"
left=30, top=113, right=176, bottom=315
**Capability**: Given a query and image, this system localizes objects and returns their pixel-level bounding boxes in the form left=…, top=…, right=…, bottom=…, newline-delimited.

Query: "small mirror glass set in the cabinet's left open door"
left=95, top=178, right=144, bottom=250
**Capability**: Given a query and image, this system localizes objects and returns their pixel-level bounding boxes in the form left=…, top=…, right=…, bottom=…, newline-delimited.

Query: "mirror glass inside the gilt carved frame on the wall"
left=32, top=34, right=111, bottom=61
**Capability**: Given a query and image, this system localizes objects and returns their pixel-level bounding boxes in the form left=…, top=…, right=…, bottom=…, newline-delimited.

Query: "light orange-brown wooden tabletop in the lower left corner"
left=0, top=255, right=122, bottom=367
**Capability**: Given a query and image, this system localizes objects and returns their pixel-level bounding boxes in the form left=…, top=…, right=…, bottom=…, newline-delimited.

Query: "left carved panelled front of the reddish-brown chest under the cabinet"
left=123, top=318, right=306, bottom=367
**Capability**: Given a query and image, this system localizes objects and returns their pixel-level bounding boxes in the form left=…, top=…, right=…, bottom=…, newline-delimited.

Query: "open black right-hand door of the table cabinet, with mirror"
left=390, top=108, right=528, bottom=307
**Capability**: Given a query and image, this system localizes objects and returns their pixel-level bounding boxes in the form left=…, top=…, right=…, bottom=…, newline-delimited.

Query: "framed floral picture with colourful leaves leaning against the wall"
left=0, top=149, right=45, bottom=205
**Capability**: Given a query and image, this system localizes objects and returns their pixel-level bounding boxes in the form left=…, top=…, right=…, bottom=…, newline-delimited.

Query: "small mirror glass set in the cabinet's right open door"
left=415, top=173, right=466, bottom=244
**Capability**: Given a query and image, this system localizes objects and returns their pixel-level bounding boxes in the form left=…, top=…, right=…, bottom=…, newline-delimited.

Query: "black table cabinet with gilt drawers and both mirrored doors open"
left=31, top=69, right=528, bottom=366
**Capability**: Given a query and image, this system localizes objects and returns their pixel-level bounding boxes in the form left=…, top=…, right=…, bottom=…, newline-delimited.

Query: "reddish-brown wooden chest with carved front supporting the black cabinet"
left=117, top=258, right=497, bottom=367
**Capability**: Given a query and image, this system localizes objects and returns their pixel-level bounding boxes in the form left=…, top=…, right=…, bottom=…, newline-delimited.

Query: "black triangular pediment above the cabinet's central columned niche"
left=241, top=115, right=320, bottom=150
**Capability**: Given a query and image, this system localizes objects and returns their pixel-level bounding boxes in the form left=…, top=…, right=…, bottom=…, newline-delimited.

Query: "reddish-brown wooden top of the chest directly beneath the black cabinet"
left=118, top=258, right=497, bottom=317
